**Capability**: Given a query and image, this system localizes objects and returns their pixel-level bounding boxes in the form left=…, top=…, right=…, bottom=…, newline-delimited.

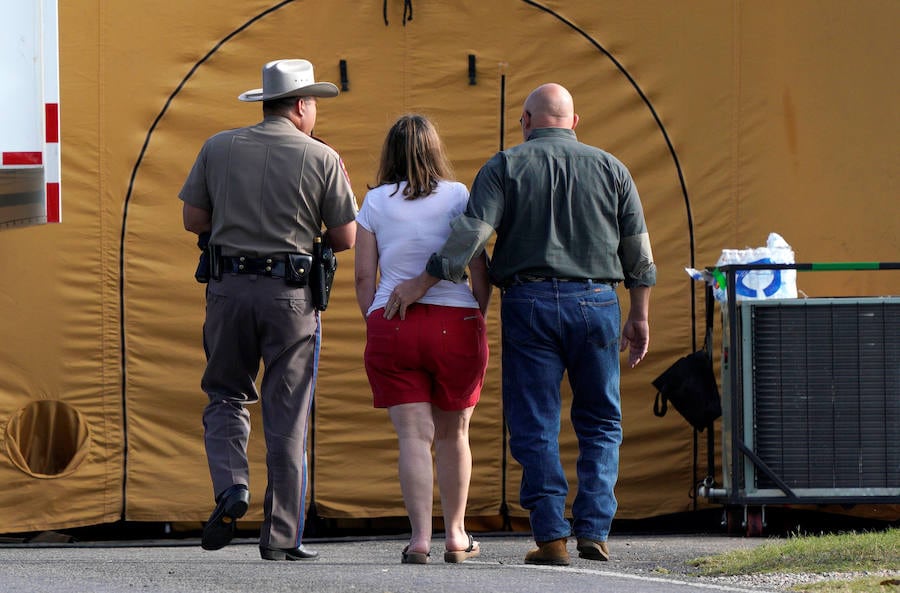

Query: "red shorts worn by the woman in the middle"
left=365, top=303, right=488, bottom=411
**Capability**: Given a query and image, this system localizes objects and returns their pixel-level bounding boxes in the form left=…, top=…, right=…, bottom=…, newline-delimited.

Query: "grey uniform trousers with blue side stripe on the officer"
left=201, top=273, right=320, bottom=548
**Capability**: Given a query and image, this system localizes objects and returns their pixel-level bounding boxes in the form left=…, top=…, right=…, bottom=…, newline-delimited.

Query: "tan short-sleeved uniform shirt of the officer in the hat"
left=179, top=116, right=358, bottom=256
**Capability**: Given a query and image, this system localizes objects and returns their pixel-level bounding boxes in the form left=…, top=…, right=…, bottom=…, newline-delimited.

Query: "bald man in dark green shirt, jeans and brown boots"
left=387, top=84, right=656, bottom=566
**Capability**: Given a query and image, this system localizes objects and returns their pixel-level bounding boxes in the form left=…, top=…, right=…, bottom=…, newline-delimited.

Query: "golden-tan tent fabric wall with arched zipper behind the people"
left=0, top=0, right=900, bottom=532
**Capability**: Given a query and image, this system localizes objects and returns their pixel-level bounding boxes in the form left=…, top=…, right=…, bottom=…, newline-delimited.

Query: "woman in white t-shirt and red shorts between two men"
left=356, top=114, right=491, bottom=564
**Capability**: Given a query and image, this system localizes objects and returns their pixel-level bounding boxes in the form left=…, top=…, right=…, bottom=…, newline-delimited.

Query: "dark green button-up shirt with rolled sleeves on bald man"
left=428, top=128, right=656, bottom=288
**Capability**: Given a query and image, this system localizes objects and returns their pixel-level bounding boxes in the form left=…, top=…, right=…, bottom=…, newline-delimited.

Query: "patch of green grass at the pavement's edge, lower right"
left=691, top=529, right=900, bottom=593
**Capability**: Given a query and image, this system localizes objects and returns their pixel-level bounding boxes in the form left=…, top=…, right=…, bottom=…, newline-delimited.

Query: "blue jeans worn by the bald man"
left=500, top=280, right=622, bottom=542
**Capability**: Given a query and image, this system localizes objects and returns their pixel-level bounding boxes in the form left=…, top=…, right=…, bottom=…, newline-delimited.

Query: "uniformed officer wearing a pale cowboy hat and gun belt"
left=179, top=59, right=357, bottom=560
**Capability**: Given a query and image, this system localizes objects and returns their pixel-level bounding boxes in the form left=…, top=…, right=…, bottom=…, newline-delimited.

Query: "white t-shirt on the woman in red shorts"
left=356, top=181, right=478, bottom=316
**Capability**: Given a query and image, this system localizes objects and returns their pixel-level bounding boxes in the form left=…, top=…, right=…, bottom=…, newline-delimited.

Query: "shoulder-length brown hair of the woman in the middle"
left=369, top=113, right=453, bottom=200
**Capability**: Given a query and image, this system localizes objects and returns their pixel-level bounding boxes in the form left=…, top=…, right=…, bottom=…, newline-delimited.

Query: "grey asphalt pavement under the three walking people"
left=0, top=533, right=778, bottom=593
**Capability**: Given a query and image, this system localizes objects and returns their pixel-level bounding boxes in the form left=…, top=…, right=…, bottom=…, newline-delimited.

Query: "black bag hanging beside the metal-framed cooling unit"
left=653, top=349, right=722, bottom=431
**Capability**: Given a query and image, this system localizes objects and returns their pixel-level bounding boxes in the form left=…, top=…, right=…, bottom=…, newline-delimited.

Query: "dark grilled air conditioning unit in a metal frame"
left=722, top=297, right=900, bottom=504
